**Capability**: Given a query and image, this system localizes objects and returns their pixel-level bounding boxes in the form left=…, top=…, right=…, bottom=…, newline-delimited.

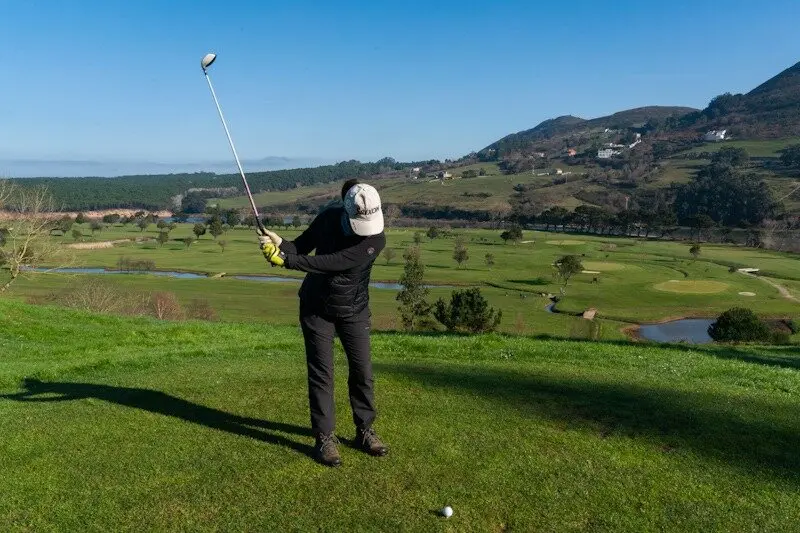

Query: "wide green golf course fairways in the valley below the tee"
left=4, top=224, right=800, bottom=339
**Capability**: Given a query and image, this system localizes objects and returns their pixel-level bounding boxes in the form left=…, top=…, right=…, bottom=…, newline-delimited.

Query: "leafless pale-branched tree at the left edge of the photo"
left=0, top=180, right=63, bottom=293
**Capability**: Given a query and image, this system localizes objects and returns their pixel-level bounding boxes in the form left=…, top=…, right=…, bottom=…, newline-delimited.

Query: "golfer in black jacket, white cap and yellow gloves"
left=259, top=180, right=388, bottom=466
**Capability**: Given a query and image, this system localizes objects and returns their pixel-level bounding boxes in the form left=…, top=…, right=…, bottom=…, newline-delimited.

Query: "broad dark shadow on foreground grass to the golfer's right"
left=375, top=362, right=800, bottom=484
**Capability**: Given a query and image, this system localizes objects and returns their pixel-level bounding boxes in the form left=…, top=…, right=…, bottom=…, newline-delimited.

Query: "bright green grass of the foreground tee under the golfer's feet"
left=0, top=300, right=800, bottom=532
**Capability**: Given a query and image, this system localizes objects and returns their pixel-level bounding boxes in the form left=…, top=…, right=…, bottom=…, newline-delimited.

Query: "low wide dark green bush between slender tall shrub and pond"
left=433, top=287, right=503, bottom=333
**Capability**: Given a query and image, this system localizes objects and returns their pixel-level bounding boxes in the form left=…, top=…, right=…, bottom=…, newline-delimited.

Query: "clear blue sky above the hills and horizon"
left=0, top=0, right=800, bottom=168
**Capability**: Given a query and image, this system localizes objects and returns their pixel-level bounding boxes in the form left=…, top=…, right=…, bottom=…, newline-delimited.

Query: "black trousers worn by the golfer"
left=300, top=306, right=376, bottom=435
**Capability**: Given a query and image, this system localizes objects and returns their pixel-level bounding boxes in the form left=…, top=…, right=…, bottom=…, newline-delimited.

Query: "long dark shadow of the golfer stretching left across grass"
left=0, top=378, right=313, bottom=456
